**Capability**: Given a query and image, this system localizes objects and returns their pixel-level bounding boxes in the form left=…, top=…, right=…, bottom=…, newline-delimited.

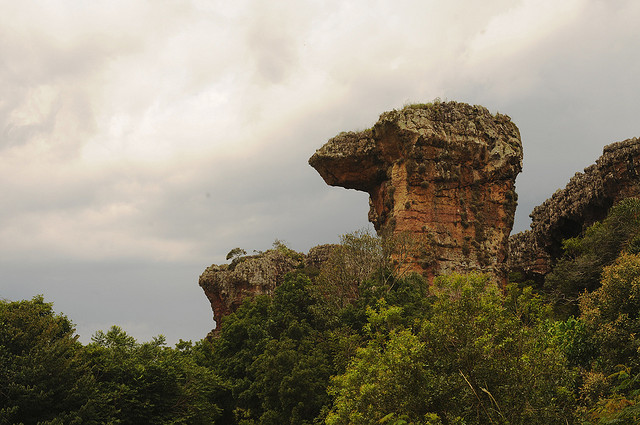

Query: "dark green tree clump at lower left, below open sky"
left=0, top=297, right=224, bottom=424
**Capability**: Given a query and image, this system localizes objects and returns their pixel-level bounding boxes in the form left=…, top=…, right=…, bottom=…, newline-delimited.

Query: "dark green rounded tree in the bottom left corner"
left=0, top=296, right=96, bottom=424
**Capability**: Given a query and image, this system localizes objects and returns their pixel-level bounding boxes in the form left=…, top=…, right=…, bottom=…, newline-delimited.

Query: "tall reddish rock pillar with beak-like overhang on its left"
left=309, top=102, right=522, bottom=281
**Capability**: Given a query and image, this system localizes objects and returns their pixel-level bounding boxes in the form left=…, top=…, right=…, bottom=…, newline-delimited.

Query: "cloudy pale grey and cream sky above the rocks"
left=0, top=0, right=640, bottom=344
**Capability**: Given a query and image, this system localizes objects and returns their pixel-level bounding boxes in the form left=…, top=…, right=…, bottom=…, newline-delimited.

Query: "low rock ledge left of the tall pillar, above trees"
left=198, top=245, right=336, bottom=329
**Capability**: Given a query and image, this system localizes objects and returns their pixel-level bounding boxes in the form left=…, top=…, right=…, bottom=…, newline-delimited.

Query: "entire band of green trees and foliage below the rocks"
left=0, top=200, right=640, bottom=425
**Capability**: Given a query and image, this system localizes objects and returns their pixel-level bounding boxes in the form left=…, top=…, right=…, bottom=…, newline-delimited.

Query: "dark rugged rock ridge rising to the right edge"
left=509, top=138, right=640, bottom=280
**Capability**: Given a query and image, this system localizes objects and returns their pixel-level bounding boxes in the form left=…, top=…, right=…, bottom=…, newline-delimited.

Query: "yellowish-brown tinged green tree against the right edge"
left=554, top=252, right=640, bottom=424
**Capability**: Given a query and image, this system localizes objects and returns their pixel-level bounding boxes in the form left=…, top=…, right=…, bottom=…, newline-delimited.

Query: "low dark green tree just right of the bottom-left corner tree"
left=84, top=326, right=224, bottom=424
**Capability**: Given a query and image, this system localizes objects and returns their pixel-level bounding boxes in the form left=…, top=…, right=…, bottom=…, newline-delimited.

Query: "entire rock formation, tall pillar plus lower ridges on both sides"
left=199, top=102, right=640, bottom=329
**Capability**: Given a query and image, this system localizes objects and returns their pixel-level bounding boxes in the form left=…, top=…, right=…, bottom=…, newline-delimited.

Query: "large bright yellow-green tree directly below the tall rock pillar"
left=327, top=276, right=573, bottom=425
